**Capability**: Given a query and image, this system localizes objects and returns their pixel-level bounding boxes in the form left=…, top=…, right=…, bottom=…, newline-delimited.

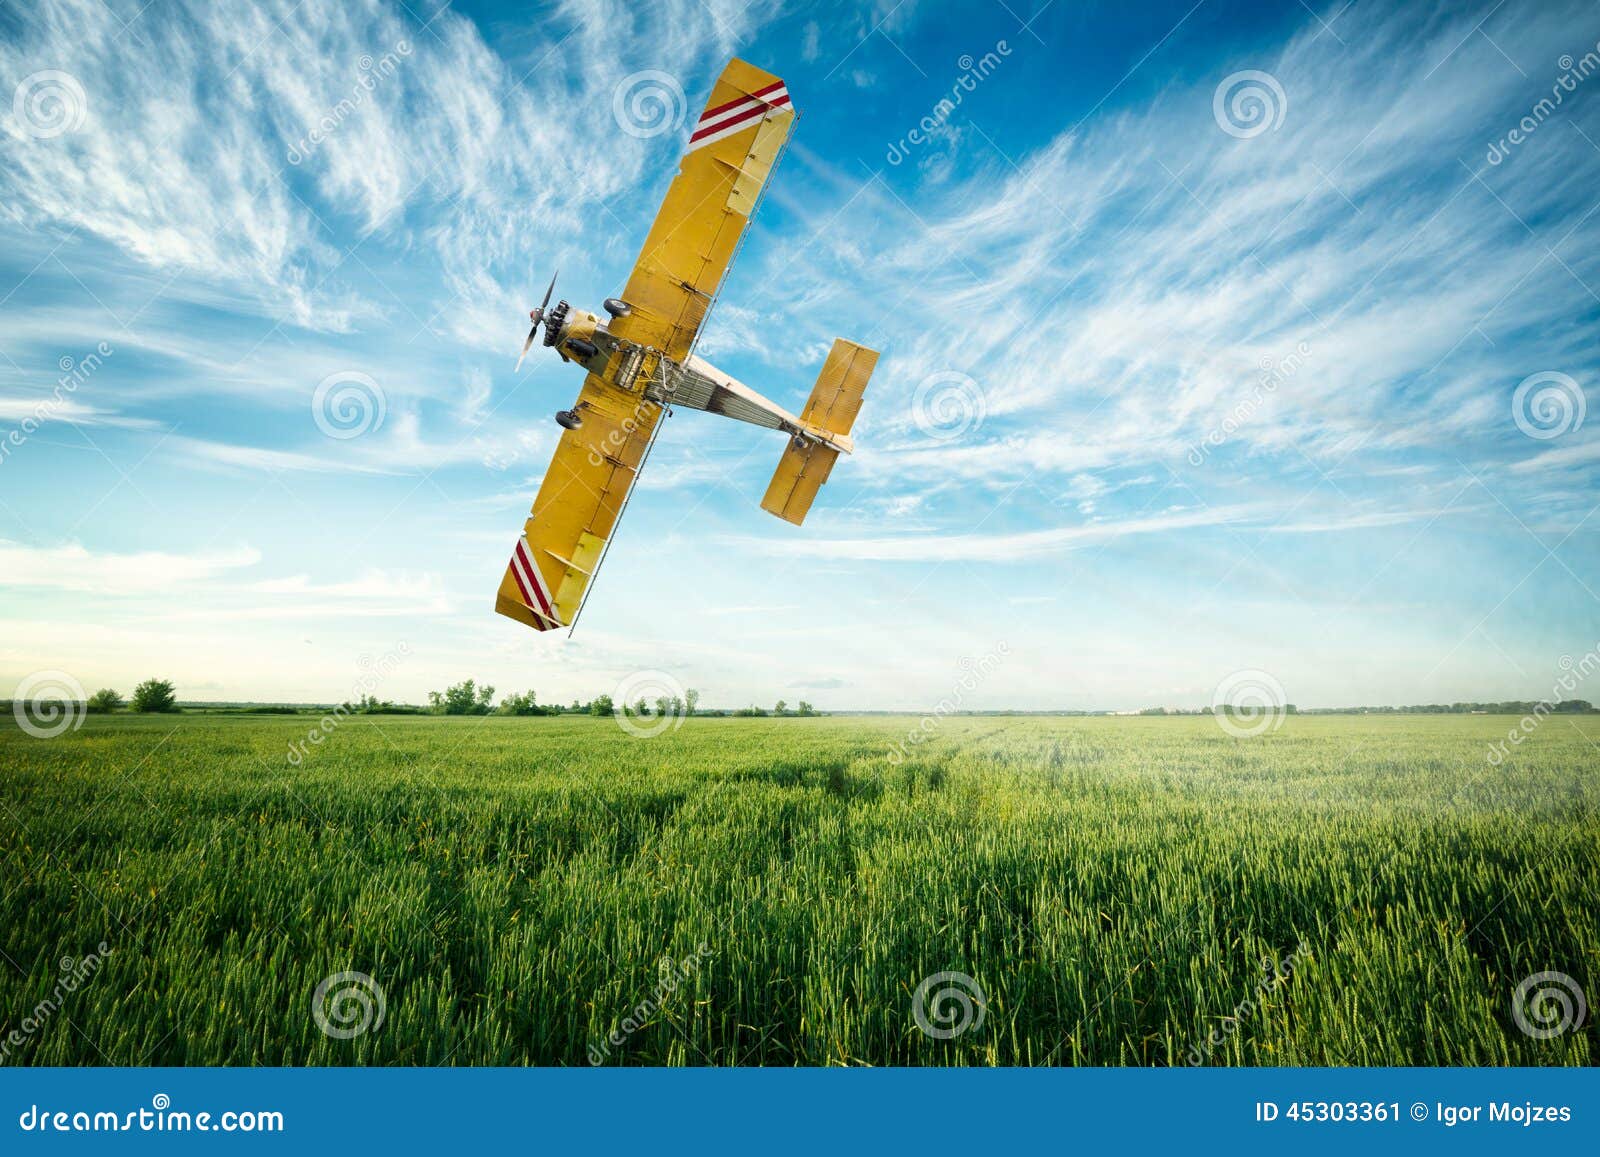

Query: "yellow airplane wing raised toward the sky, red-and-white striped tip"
left=610, top=59, right=795, bottom=360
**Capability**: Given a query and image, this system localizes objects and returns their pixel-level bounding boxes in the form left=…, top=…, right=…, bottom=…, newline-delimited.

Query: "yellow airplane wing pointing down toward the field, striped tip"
left=494, top=374, right=661, bottom=631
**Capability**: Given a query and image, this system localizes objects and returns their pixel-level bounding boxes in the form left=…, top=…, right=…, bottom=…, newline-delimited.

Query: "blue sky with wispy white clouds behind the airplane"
left=0, top=0, right=1600, bottom=711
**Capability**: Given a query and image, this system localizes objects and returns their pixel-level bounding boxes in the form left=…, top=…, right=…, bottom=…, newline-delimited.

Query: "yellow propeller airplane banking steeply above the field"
left=494, top=61, right=878, bottom=631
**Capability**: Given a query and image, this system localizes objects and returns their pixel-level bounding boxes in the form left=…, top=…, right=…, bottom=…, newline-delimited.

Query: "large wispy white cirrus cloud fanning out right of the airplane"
left=729, top=6, right=1600, bottom=512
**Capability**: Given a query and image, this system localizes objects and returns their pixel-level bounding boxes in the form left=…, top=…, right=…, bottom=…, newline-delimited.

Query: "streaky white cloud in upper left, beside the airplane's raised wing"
left=0, top=0, right=766, bottom=341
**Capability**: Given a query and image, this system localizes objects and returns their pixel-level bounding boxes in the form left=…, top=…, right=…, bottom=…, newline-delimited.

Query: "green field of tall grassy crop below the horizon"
left=0, top=715, right=1600, bottom=1066
